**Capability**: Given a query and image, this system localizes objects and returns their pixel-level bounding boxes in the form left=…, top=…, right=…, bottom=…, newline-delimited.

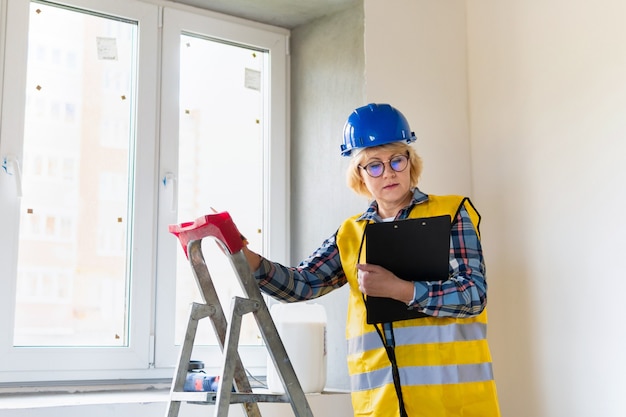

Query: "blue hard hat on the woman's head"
left=341, top=103, right=416, bottom=156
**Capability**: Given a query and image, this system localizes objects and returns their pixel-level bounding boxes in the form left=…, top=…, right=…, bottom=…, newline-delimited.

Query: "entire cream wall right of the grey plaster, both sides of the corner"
left=365, top=0, right=626, bottom=417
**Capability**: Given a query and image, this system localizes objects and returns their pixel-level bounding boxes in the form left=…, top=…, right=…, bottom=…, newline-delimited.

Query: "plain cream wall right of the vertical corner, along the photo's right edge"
left=467, top=0, right=626, bottom=417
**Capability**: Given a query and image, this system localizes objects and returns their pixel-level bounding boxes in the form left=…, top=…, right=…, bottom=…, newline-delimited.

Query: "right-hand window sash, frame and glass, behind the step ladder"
left=156, top=9, right=287, bottom=376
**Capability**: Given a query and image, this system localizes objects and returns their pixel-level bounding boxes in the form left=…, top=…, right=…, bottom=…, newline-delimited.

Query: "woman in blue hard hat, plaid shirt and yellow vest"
left=244, top=104, right=500, bottom=417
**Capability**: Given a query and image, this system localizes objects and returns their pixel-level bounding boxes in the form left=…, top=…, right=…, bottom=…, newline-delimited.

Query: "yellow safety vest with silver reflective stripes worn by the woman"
left=337, top=196, right=500, bottom=417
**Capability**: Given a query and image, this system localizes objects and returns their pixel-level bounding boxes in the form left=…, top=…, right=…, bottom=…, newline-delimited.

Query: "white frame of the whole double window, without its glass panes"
left=0, top=0, right=289, bottom=385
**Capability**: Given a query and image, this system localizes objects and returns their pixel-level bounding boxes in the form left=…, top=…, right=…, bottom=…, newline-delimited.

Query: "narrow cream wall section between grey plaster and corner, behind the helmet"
left=365, top=0, right=471, bottom=195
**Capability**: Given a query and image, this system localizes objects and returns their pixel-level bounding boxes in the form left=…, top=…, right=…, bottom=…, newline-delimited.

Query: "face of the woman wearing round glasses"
left=359, top=148, right=411, bottom=213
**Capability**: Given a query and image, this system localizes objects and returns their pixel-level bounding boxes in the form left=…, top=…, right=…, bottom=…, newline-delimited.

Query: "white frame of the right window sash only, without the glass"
left=155, top=8, right=289, bottom=374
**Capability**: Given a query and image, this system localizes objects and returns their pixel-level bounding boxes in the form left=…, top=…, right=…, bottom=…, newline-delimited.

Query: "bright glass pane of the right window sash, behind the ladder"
left=176, top=34, right=267, bottom=345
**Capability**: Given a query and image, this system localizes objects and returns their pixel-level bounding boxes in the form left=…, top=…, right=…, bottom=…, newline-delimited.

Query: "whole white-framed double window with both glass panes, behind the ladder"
left=0, top=0, right=287, bottom=382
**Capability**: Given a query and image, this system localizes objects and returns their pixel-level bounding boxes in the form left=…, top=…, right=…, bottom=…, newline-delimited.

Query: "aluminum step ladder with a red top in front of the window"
left=166, top=212, right=313, bottom=417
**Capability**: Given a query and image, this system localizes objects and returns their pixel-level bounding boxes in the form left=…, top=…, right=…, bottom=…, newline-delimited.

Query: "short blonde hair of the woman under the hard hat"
left=346, top=141, right=422, bottom=198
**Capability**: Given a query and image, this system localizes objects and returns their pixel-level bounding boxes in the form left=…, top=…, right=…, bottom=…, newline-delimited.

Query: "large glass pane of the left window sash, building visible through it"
left=13, top=2, right=137, bottom=346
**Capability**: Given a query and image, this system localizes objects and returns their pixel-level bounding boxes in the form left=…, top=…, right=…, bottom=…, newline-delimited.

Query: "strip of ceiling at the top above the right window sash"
left=174, top=0, right=360, bottom=29
